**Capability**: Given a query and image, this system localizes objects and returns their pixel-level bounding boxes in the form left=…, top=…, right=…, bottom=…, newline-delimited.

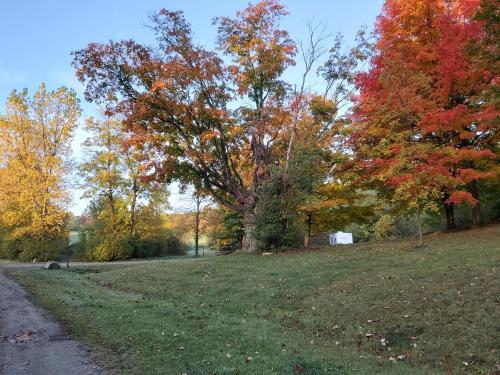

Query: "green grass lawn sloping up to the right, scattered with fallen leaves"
left=7, top=226, right=500, bottom=375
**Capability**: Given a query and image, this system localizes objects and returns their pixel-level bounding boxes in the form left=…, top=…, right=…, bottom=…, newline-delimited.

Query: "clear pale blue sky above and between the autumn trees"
left=0, top=0, right=383, bottom=214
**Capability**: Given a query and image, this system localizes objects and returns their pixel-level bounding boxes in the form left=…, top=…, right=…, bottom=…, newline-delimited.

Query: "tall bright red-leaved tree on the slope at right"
left=351, top=0, right=499, bottom=229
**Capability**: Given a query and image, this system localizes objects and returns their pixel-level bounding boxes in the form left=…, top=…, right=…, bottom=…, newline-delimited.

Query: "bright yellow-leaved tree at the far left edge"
left=0, top=84, right=80, bottom=260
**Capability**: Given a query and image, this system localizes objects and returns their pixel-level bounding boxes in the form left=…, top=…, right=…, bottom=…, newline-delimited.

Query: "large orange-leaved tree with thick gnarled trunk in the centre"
left=74, top=0, right=296, bottom=251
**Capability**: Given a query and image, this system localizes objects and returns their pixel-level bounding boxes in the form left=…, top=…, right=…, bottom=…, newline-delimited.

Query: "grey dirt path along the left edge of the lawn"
left=0, top=267, right=102, bottom=375
